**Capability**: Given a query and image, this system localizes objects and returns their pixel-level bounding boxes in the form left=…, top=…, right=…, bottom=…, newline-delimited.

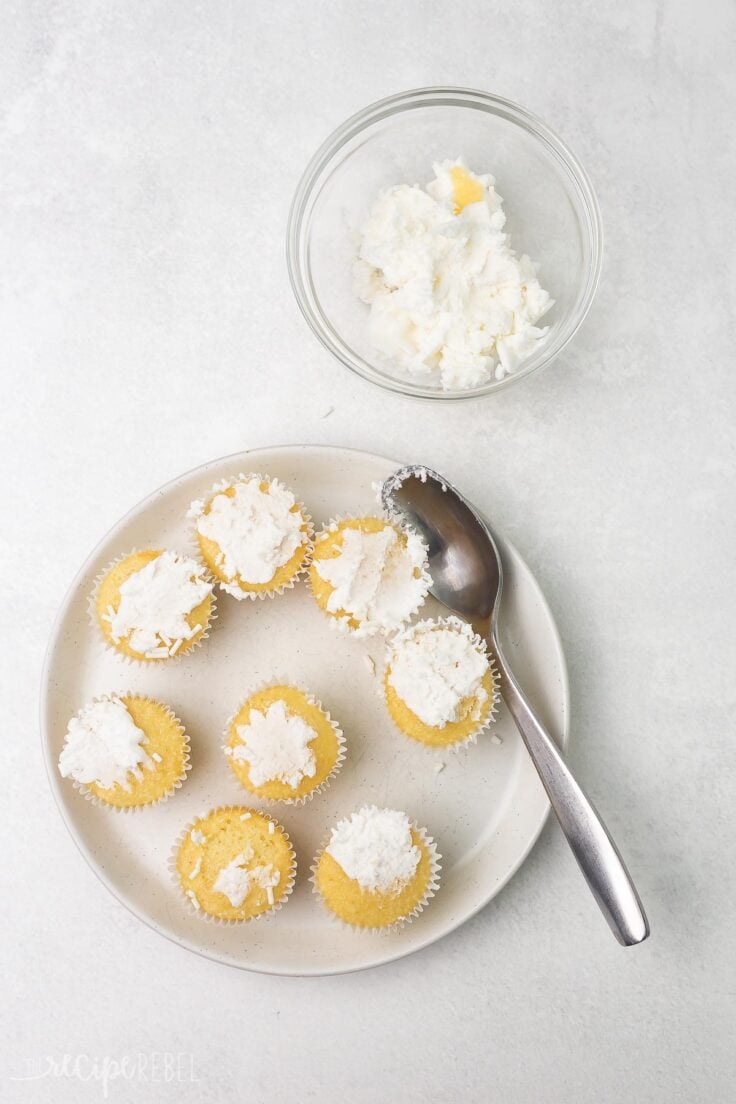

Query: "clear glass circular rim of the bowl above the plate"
left=286, top=85, right=604, bottom=402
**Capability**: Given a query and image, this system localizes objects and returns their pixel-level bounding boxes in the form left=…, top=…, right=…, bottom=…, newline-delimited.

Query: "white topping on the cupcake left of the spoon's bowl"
left=314, top=522, right=429, bottom=636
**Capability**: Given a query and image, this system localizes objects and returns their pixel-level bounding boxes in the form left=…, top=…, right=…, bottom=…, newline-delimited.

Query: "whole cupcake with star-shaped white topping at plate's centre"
left=224, top=684, right=345, bottom=805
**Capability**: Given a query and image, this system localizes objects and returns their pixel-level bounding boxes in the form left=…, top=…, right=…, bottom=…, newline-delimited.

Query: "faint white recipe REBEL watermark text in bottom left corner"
left=10, top=1051, right=200, bottom=1100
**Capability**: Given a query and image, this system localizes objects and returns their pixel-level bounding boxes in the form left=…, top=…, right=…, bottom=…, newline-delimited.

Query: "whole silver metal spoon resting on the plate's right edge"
left=381, top=465, right=649, bottom=946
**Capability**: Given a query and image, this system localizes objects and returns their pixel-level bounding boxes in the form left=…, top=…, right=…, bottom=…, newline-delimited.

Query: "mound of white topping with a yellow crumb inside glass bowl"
left=355, top=158, right=554, bottom=391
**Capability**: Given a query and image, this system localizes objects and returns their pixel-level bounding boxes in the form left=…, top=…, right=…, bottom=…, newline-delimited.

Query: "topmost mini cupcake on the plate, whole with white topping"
left=188, top=475, right=312, bottom=599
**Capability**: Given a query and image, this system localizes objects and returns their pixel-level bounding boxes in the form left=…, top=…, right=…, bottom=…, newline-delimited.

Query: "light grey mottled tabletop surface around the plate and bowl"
left=0, top=0, right=736, bottom=1104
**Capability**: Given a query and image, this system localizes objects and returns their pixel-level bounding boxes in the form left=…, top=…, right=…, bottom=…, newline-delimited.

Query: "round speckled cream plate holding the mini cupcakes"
left=41, top=446, right=568, bottom=975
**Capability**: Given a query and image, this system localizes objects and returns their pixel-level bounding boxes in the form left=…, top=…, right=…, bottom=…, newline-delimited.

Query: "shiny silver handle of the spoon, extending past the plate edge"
left=493, top=639, right=649, bottom=947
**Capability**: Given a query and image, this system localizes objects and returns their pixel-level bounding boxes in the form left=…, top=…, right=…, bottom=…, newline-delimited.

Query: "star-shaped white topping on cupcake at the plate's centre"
left=231, top=701, right=317, bottom=788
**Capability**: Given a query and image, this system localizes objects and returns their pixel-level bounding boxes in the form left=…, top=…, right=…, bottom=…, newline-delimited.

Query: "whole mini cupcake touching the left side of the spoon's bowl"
left=309, top=518, right=429, bottom=636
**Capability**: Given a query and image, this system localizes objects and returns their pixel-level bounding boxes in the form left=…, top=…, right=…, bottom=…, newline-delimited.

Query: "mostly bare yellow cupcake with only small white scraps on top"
left=171, top=806, right=296, bottom=923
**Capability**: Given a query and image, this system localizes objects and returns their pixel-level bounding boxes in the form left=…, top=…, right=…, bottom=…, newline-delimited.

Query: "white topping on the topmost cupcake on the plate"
left=189, top=475, right=305, bottom=597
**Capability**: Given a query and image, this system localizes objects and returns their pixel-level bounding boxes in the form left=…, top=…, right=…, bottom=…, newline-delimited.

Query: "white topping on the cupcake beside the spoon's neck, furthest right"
left=387, top=617, right=490, bottom=728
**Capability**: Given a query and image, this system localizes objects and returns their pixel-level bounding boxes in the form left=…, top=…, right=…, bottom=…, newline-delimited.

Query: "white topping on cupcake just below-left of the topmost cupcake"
left=102, top=552, right=212, bottom=659
